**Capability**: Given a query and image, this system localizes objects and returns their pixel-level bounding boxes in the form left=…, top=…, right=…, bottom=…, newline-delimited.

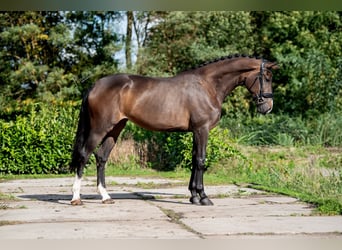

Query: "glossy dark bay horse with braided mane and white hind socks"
left=70, top=56, right=278, bottom=205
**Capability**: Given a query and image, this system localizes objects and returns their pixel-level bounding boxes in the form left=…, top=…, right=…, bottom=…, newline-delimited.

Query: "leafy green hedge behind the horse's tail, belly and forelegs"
left=0, top=99, right=246, bottom=174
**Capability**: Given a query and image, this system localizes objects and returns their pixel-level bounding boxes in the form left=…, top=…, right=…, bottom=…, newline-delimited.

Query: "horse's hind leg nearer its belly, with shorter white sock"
left=95, top=120, right=127, bottom=204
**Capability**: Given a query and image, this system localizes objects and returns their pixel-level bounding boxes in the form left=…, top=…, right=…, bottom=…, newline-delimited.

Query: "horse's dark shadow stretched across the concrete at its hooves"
left=18, top=192, right=187, bottom=205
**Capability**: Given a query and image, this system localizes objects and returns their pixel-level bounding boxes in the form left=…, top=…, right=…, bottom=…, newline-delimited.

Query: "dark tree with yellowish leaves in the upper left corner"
left=0, top=11, right=75, bottom=103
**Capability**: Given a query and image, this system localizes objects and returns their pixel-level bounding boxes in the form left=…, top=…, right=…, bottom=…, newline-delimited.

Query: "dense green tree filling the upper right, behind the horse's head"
left=256, top=11, right=342, bottom=115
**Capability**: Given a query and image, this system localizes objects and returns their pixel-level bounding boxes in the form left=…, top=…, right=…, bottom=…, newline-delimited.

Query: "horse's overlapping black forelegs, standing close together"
left=189, top=128, right=213, bottom=205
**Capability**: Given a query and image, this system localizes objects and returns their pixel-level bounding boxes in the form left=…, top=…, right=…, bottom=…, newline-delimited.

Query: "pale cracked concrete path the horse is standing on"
left=0, top=177, right=342, bottom=239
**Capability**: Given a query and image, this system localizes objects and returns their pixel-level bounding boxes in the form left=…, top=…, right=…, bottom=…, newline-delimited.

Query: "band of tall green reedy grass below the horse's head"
left=221, top=113, right=342, bottom=147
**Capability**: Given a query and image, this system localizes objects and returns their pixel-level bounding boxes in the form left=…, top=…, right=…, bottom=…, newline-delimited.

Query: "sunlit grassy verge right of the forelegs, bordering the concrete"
left=219, top=146, right=342, bottom=215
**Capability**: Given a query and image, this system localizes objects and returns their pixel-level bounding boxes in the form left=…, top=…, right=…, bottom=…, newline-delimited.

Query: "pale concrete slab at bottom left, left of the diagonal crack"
left=0, top=220, right=199, bottom=240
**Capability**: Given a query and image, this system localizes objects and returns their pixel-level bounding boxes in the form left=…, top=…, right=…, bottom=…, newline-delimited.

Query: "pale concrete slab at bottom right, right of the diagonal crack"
left=183, top=216, right=342, bottom=236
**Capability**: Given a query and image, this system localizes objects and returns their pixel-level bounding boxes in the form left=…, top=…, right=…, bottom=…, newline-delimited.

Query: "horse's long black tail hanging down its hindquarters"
left=70, top=90, right=90, bottom=172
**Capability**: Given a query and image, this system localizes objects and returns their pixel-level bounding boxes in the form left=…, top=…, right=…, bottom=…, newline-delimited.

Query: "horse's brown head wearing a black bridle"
left=245, top=61, right=279, bottom=114
